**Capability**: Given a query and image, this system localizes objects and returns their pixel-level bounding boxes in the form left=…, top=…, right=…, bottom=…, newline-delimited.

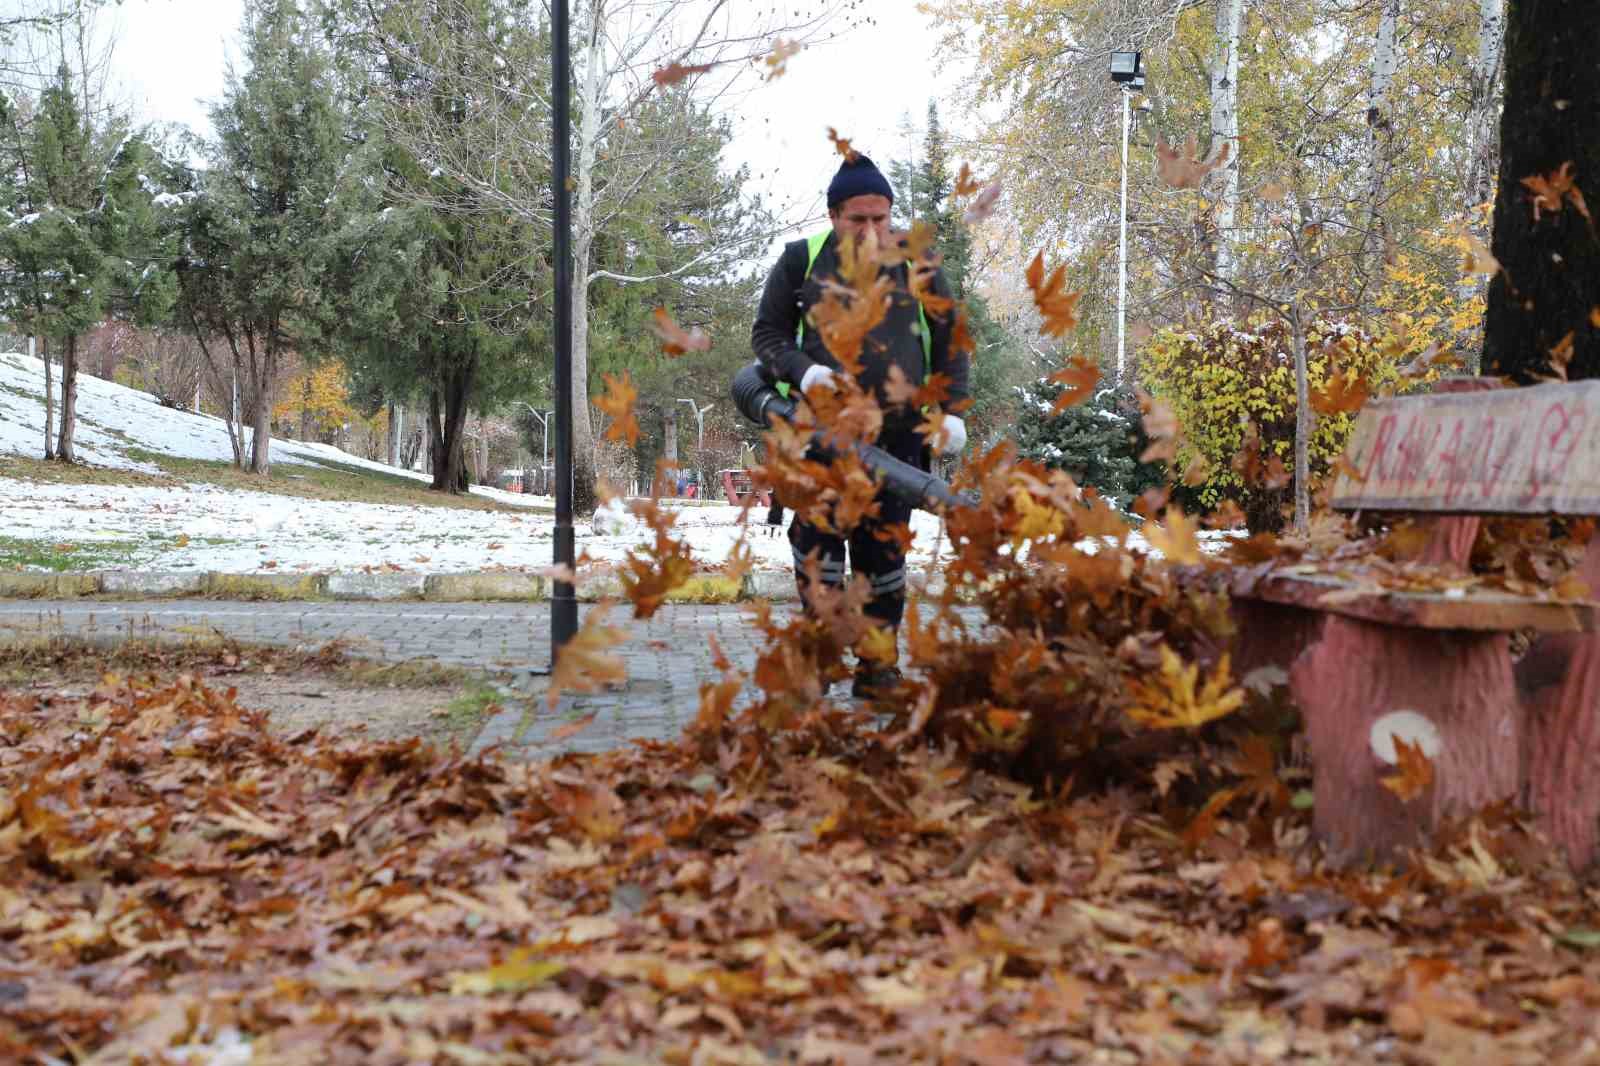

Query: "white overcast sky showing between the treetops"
left=106, top=0, right=960, bottom=244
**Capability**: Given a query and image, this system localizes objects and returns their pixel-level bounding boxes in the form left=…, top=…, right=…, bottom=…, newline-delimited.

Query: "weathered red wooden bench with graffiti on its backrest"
left=1232, top=378, right=1600, bottom=869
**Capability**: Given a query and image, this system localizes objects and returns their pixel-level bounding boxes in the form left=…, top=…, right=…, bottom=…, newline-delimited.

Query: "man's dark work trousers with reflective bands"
left=789, top=437, right=926, bottom=629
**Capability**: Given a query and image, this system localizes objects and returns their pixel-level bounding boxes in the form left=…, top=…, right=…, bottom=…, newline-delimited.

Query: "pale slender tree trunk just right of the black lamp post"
left=573, top=0, right=605, bottom=515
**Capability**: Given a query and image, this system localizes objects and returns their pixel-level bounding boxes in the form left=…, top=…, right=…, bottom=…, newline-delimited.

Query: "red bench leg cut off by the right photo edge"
left=1517, top=546, right=1600, bottom=871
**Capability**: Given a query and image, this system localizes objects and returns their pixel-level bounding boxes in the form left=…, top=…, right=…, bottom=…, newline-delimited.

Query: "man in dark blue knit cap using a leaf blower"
left=750, top=154, right=968, bottom=698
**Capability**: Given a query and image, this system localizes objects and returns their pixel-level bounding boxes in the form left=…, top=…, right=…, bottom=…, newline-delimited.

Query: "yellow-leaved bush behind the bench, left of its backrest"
left=1139, top=317, right=1408, bottom=530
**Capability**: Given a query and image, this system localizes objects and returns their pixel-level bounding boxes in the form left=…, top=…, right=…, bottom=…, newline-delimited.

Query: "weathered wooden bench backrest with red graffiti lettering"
left=1333, top=381, right=1600, bottom=515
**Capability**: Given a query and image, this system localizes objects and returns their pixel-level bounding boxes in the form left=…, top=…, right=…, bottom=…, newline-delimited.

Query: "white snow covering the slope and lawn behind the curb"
left=0, top=354, right=939, bottom=573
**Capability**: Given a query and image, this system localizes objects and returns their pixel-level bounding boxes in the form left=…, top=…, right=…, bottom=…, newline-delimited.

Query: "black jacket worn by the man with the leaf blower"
left=750, top=234, right=968, bottom=429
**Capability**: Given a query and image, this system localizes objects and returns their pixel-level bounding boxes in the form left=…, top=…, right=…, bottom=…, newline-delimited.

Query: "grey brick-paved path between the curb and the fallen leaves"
left=0, top=600, right=806, bottom=759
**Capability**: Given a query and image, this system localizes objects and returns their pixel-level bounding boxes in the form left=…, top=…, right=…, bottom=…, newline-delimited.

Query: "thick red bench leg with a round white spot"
left=1290, top=616, right=1522, bottom=864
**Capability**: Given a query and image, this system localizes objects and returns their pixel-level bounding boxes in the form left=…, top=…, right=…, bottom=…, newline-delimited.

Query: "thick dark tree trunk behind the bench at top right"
left=1483, top=0, right=1600, bottom=384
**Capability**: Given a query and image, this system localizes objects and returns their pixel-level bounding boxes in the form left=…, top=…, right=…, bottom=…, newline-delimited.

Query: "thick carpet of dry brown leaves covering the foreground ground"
left=0, top=677, right=1600, bottom=1063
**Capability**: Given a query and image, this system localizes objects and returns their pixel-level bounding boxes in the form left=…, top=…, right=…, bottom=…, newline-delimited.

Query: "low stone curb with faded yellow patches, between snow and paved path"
left=0, top=570, right=812, bottom=603
